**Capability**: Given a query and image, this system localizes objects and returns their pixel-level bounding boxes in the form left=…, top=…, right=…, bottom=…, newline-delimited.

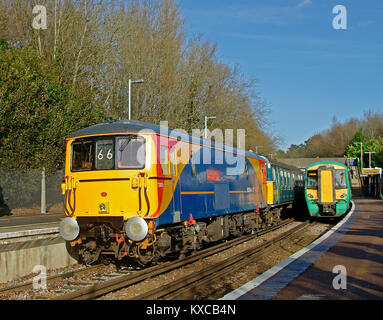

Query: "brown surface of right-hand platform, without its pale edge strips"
left=273, top=199, right=383, bottom=300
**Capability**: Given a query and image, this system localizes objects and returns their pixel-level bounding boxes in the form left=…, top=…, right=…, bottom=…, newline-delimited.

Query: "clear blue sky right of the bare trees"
left=177, top=0, right=383, bottom=149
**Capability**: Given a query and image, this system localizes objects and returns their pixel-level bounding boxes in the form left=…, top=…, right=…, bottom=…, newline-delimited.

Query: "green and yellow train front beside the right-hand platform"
left=305, top=160, right=351, bottom=217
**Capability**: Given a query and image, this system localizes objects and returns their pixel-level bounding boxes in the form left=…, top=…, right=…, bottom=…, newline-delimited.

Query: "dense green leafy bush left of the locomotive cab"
left=0, top=49, right=103, bottom=174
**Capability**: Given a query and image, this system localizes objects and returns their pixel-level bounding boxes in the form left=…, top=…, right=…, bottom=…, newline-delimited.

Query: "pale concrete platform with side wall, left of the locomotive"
left=0, top=213, right=77, bottom=283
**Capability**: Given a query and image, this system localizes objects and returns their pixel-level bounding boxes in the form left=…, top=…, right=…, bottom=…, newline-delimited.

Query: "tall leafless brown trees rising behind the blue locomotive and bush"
left=0, top=0, right=277, bottom=153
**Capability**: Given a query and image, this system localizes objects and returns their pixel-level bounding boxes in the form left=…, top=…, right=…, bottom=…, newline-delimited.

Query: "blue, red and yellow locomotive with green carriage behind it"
left=60, top=120, right=304, bottom=265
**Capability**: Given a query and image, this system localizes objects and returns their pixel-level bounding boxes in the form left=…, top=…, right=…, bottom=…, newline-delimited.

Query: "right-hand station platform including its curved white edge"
left=221, top=198, right=383, bottom=300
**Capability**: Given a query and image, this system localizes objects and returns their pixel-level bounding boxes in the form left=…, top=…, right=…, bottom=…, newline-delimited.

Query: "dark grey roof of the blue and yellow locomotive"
left=68, top=119, right=269, bottom=162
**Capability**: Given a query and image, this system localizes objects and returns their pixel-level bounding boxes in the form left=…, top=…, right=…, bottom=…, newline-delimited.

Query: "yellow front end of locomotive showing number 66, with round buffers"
left=60, top=133, right=158, bottom=264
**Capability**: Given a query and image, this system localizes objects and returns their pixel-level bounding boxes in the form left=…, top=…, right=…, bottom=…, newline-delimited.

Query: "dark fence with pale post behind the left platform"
left=0, top=169, right=64, bottom=216
